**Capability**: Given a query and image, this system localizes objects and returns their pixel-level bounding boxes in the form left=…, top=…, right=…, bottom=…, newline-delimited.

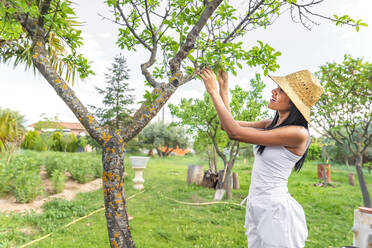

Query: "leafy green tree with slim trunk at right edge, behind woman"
left=313, top=55, right=372, bottom=207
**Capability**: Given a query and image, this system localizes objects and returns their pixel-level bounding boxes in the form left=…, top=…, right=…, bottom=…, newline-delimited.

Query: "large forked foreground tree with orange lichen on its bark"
left=0, top=0, right=365, bottom=247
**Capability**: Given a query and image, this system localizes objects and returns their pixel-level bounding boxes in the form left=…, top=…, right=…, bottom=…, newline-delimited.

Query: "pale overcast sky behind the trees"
left=0, top=0, right=372, bottom=135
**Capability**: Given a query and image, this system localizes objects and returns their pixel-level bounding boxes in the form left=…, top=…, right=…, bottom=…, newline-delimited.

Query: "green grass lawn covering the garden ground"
left=0, top=154, right=372, bottom=248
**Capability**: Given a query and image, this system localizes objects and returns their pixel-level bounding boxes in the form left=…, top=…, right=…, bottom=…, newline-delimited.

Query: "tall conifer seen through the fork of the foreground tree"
left=90, top=54, right=134, bottom=130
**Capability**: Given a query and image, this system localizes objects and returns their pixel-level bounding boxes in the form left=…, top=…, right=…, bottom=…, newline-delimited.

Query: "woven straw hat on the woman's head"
left=269, top=70, right=323, bottom=123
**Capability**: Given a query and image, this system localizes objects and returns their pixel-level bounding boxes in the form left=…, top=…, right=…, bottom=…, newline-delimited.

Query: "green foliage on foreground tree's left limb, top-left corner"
left=0, top=0, right=94, bottom=82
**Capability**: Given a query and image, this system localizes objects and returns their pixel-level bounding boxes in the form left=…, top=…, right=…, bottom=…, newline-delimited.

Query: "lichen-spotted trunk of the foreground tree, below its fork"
left=102, top=145, right=135, bottom=248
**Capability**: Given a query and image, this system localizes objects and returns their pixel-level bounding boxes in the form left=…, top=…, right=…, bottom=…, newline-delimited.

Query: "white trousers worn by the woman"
left=242, top=193, right=308, bottom=248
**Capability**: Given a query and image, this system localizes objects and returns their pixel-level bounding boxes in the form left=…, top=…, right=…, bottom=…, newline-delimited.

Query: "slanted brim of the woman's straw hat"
left=269, top=75, right=310, bottom=124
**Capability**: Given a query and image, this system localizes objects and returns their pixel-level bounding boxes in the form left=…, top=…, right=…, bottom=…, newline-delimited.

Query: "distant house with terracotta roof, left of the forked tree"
left=27, top=121, right=87, bottom=136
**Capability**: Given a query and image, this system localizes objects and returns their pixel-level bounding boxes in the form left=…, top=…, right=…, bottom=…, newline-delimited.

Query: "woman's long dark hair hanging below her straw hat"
left=257, top=101, right=309, bottom=172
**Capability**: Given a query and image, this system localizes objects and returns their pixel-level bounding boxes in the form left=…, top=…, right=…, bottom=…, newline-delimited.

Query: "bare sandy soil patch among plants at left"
left=0, top=167, right=102, bottom=213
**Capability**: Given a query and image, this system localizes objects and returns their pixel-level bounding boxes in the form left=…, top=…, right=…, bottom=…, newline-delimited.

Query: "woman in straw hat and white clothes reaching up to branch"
left=198, top=69, right=323, bottom=248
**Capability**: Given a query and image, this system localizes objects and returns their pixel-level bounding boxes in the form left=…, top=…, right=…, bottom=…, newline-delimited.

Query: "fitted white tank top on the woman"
left=248, top=130, right=311, bottom=197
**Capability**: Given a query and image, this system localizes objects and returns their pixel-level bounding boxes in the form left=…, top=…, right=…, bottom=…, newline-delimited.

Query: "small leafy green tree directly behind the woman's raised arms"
left=168, top=74, right=267, bottom=199
